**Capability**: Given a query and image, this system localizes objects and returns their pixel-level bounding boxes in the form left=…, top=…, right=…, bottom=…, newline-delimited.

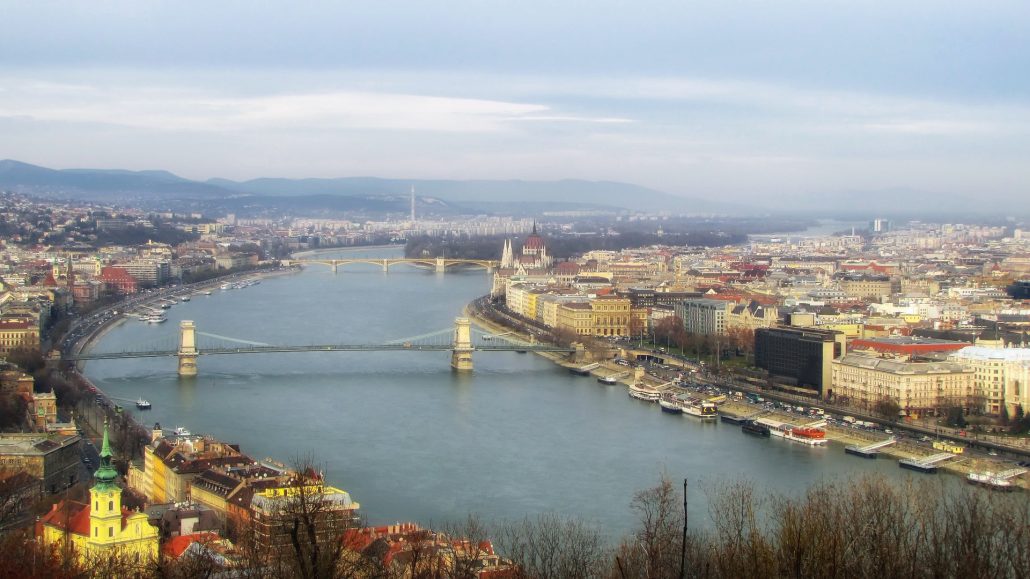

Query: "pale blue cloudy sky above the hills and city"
left=0, top=0, right=1030, bottom=205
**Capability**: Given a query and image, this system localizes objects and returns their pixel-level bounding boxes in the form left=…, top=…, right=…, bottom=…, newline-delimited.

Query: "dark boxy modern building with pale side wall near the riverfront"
left=755, top=327, right=845, bottom=398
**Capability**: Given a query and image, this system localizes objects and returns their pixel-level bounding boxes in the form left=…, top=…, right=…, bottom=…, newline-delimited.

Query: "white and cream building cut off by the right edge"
left=948, top=346, right=1030, bottom=417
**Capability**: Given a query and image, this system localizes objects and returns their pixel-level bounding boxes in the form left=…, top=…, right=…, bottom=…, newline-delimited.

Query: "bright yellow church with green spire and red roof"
left=39, top=418, right=159, bottom=564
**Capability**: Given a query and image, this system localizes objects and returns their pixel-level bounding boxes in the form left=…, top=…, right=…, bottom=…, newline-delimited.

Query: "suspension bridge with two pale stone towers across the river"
left=62, top=317, right=583, bottom=376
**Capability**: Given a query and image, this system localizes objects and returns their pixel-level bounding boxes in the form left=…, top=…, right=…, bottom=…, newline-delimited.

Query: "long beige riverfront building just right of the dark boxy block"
left=831, top=353, right=975, bottom=415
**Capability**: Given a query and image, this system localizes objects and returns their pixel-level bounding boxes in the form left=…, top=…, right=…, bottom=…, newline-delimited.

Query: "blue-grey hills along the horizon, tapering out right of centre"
left=0, top=160, right=741, bottom=214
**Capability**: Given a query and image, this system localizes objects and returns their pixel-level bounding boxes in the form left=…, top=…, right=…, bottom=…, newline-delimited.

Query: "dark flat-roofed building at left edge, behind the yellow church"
left=0, top=433, right=82, bottom=493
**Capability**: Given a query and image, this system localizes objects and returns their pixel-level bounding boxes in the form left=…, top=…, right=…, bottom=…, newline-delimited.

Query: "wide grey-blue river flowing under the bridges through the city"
left=85, top=248, right=943, bottom=536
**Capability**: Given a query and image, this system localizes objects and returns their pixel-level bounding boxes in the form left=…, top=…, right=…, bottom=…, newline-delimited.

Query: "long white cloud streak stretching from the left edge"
left=0, top=76, right=628, bottom=133
